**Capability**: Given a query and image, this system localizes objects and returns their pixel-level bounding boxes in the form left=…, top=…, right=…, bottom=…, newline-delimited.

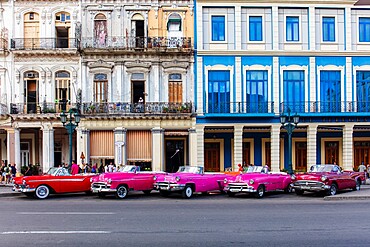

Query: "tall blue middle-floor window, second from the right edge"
left=320, top=71, right=341, bottom=112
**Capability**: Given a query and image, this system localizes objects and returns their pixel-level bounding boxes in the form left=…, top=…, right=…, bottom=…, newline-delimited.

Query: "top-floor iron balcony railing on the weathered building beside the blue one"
left=82, top=37, right=192, bottom=50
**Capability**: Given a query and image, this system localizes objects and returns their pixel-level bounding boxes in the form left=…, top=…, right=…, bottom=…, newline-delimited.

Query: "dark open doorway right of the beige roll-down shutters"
left=165, top=140, right=185, bottom=172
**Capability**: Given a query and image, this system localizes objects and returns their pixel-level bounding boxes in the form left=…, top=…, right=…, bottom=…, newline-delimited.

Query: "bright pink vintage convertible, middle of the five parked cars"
left=155, top=166, right=231, bottom=198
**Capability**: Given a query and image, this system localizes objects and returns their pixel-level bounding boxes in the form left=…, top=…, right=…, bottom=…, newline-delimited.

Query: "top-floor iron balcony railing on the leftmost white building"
left=10, top=38, right=78, bottom=50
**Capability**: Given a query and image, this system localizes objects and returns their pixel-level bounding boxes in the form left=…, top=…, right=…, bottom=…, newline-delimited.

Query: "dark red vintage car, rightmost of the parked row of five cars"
left=292, top=165, right=365, bottom=195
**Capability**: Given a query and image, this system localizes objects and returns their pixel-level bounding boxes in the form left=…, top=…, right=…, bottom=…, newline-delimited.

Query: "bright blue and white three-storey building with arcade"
left=194, top=0, right=370, bottom=171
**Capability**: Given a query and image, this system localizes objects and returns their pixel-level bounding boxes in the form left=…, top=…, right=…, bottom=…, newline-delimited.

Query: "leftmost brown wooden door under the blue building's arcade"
left=204, top=142, right=220, bottom=172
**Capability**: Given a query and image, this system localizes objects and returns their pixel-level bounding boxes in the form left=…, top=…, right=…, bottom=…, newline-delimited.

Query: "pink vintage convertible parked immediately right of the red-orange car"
left=91, top=166, right=160, bottom=199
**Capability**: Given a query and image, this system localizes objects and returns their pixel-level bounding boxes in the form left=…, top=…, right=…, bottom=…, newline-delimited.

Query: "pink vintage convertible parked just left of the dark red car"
left=224, top=166, right=292, bottom=198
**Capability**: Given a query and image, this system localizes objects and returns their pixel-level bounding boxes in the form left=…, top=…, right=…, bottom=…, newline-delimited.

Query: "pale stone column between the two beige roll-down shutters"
left=114, top=127, right=127, bottom=165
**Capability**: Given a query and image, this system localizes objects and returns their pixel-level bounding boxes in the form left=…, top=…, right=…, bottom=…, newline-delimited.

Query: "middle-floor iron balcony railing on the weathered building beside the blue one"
left=81, top=102, right=194, bottom=115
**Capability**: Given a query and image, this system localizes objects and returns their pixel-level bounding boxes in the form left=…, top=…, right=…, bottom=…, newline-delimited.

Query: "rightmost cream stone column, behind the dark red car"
left=339, top=123, right=353, bottom=170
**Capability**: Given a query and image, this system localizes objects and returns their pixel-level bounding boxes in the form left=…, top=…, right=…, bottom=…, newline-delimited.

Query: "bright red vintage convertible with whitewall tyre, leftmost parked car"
left=13, top=167, right=96, bottom=199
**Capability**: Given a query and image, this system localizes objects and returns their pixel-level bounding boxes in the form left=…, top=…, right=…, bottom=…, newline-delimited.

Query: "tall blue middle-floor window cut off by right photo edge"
left=356, top=71, right=370, bottom=112
